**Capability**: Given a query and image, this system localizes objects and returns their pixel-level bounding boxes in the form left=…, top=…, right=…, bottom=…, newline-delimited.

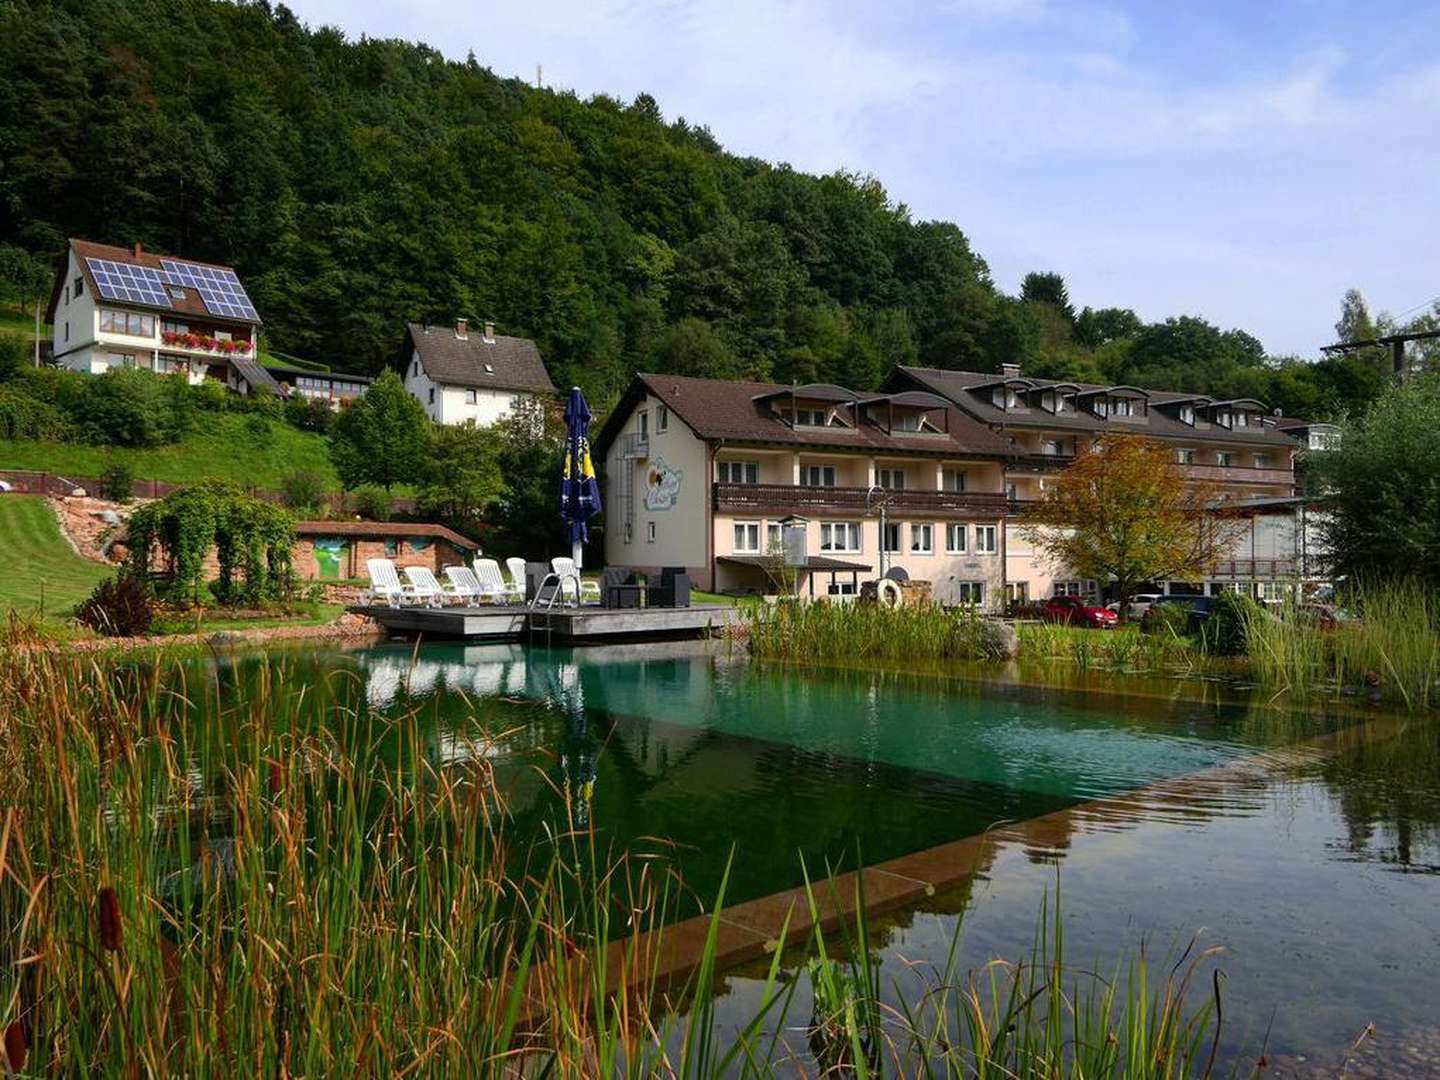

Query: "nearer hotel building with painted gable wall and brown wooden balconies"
left=595, top=374, right=1009, bottom=605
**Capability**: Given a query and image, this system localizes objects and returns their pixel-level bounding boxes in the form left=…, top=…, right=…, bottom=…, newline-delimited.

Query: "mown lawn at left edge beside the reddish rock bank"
left=0, top=495, right=111, bottom=616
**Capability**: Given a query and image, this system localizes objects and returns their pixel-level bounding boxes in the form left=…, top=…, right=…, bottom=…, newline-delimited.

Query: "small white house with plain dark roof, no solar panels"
left=402, top=318, right=554, bottom=426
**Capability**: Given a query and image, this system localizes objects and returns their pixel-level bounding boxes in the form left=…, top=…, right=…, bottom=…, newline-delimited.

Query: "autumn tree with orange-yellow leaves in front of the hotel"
left=1021, top=435, right=1246, bottom=605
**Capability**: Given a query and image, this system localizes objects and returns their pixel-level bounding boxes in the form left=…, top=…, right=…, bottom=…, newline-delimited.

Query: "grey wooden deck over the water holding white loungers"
left=350, top=605, right=737, bottom=641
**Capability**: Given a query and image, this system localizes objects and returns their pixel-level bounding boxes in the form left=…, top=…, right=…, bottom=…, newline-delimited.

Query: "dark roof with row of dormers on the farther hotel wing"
left=886, top=366, right=1295, bottom=449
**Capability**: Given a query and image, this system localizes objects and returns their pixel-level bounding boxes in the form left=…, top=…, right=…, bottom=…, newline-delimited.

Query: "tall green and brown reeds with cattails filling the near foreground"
left=0, top=649, right=1249, bottom=1077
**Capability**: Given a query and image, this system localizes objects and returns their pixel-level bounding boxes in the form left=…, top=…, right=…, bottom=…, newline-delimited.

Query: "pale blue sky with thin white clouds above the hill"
left=287, top=0, right=1440, bottom=357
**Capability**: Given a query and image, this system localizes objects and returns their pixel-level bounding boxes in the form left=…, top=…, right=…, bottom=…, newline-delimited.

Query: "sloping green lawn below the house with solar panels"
left=0, top=413, right=340, bottom=490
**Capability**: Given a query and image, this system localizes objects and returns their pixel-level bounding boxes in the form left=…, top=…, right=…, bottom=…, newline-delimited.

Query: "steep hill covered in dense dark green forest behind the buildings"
left=0, top=0, right=1378, bottom=415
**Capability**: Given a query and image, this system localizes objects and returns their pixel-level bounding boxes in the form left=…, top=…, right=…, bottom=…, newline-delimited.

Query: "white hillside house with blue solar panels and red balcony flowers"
left=49, top=240, right=261, bottom=389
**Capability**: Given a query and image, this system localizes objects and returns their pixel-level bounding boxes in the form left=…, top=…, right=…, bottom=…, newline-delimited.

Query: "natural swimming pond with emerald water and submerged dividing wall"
left=165, top=645, right=1440, bottom=1077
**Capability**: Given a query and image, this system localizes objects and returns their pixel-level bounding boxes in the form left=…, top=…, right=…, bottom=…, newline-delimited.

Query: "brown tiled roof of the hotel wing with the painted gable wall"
left=596, top=374, right=1009, bottom=458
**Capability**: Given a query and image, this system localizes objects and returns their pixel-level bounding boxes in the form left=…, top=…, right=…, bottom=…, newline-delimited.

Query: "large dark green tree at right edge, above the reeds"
left=1308, top=376, right=1440, bottom=586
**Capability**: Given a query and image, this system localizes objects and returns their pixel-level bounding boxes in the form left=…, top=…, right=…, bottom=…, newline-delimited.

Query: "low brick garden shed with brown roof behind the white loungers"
left=294, top=521, right=480, bottom=580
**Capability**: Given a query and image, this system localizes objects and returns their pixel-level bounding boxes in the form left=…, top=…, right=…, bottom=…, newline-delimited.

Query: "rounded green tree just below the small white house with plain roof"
left=330, top=370, right=431, bottom=491
